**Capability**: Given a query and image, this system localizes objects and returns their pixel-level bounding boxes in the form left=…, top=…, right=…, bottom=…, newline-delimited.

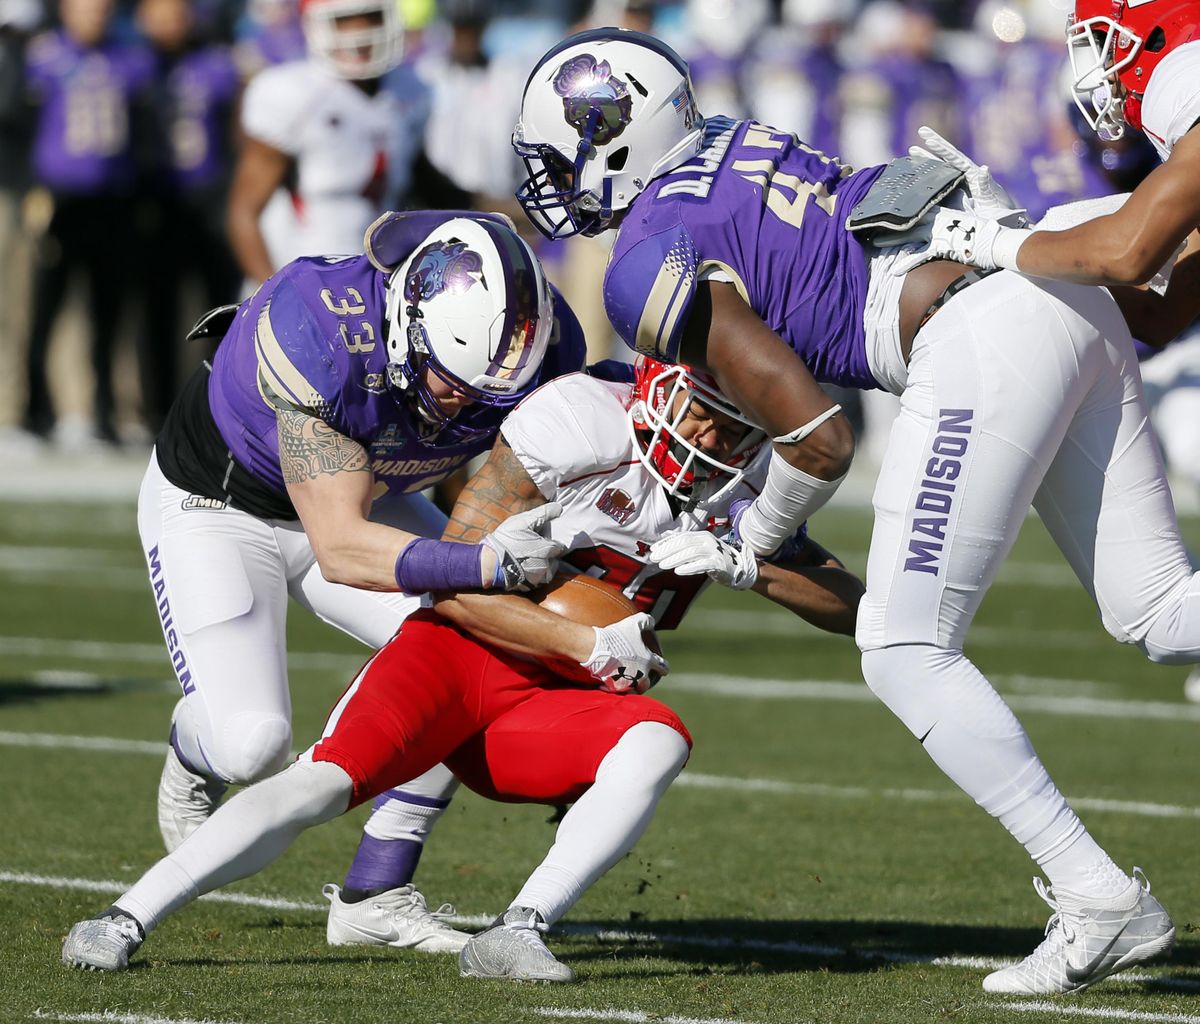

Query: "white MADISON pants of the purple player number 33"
left=138, top=455, right=452, bottom=792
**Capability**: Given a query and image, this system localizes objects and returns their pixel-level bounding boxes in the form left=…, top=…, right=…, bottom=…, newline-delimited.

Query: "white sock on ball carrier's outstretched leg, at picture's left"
left=114, top=761, right=353, bottom=934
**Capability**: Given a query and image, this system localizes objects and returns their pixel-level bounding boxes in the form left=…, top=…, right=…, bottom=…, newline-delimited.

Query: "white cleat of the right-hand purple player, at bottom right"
left=983, top=868, right=1175, bottom=995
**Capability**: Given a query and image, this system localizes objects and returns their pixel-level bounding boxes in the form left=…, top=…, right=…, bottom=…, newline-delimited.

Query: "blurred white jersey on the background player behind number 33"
left=241, top=60, right=422, bottom=267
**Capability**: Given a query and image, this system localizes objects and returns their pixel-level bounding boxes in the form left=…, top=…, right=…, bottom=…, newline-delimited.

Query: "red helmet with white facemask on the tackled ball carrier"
left=629, top=355, right=767, bottom=504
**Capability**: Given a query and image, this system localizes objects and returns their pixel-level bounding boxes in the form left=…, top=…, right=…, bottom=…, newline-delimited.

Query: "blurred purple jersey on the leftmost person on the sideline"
left=25, top=30, right=154, bottom=193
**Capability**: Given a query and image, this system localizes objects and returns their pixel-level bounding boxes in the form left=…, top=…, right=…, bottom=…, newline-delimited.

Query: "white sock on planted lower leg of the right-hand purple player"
left=863, top=643, right=1129, bottom=899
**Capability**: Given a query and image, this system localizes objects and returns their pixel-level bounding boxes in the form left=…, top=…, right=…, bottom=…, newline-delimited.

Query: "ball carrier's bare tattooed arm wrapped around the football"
left=433, top=437, right=595, bottom=661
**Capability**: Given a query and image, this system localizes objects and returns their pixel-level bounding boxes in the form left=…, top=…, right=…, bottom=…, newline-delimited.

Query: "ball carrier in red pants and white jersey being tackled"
left=62, top=360, right=862, bottom=982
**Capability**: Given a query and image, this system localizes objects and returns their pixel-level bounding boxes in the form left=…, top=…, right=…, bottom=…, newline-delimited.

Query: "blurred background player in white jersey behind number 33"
left=228, top=0, right=427, bottom=286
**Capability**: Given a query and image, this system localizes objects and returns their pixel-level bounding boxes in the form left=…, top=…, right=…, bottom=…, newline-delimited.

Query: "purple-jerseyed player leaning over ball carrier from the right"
left=514, top=29, right=1200, bottom=993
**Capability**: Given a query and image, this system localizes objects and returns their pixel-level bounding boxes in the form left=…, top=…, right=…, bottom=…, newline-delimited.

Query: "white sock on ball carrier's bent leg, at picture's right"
left=509, top=721, right=689, bottom=924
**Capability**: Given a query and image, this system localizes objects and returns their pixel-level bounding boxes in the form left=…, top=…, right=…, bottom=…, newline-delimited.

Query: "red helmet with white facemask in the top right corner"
left=1067, top=0, right=1200, bottom=139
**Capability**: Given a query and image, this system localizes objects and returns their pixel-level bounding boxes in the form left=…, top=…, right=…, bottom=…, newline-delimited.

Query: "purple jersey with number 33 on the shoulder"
left=209, top=214, right=586, bottom=499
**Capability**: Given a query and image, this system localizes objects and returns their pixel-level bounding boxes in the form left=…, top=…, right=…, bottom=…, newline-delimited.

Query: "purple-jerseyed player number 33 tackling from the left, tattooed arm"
left=145, top=212, right=583, bottom=950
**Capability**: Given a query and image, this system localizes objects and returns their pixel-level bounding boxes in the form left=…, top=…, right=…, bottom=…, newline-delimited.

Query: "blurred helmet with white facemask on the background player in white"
left=300, top=0, right=404, bottom=79
